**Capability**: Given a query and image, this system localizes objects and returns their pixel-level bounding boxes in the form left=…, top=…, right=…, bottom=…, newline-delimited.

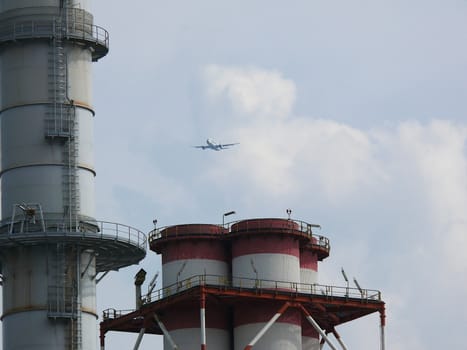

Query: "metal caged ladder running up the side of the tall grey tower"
left=45, top=0, right=82, bottom=350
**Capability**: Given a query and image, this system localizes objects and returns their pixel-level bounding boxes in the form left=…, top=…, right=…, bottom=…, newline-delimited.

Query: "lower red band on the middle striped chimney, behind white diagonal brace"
left=234, top=302, right=301, bottom=327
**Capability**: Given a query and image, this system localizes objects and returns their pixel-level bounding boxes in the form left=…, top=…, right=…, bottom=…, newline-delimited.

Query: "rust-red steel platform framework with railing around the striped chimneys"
left=100, top=285, right=385, bottom=350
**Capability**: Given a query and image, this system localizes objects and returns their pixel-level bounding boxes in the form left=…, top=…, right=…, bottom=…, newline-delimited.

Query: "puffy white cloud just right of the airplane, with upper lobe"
left=205, top=65, right=390, bottom=201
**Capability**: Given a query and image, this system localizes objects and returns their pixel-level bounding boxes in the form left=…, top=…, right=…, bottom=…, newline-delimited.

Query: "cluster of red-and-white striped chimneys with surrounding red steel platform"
left=100, top=219, right=385, bottom=350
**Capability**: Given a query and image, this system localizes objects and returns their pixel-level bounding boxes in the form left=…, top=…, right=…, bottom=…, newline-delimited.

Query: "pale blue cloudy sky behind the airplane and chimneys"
left=88, top=0, right=467, bottom=350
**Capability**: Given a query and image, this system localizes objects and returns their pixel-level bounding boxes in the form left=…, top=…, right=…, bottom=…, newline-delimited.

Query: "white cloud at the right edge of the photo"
left=397, top=121, right=467, bottom=274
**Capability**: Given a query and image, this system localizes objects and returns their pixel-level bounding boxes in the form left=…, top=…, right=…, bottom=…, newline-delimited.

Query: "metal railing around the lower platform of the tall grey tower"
left=0, top=218, right=146, bottom=251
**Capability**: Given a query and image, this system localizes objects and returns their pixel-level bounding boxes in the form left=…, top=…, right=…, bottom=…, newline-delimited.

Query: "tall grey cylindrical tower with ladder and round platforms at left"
left=0, top=0, right=145, bottom=350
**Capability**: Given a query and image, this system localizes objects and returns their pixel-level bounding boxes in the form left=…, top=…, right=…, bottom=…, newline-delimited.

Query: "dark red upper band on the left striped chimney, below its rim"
left=162, top=239, right=230, bottom=264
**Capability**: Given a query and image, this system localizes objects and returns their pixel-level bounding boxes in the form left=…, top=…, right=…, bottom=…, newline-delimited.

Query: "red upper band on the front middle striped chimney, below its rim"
left=232, top=236, right=300, bottom=258
